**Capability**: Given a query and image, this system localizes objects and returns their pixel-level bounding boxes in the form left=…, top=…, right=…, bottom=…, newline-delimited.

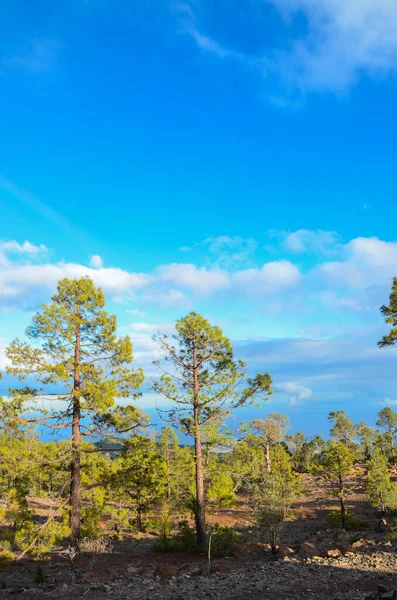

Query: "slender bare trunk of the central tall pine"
left=193, top=341, right=206, bottom=546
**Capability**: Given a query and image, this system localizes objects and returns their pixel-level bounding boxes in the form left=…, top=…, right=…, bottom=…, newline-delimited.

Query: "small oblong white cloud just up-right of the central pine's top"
left=232, top=260, right=301, bottom=295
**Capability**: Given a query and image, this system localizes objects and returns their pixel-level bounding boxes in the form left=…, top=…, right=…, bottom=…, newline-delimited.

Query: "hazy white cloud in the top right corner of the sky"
left=268, top=0, right=397, bottom=92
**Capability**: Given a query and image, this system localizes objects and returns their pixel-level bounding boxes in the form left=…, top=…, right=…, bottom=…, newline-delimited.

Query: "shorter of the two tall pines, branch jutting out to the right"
left=154, top=312, right=271, bottom=546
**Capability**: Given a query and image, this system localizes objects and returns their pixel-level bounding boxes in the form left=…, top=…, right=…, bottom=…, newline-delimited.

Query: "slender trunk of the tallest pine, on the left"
left=69, top=327, right=81, bottom=550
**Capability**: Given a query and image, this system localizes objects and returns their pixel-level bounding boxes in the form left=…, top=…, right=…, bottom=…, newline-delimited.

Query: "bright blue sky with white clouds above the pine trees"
left=0, top=0, right=397, bottom=434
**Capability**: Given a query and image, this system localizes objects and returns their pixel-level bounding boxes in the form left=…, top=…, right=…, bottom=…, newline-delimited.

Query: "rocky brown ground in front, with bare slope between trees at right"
left=0, top=472, right=397, bottom=600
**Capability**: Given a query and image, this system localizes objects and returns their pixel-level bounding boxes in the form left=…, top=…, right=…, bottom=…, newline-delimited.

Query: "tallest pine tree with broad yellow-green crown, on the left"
left=1, top=277, right=143, bottom=549
